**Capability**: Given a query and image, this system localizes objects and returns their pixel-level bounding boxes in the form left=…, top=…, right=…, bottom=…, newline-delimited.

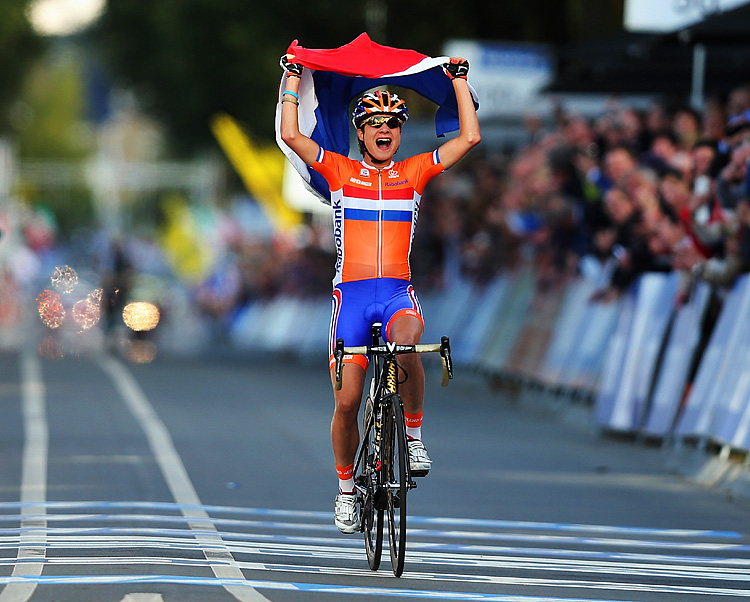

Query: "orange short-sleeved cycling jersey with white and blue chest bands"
left=312, top=148, right=444, bottom=286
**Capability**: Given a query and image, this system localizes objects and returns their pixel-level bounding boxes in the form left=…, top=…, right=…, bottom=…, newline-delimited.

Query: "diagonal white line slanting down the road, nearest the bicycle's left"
left=95, top=356, right=268, bottom=602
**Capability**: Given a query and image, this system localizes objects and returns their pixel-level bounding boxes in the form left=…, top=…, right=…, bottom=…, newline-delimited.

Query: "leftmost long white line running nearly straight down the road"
left=0, top=350, right=49, bottom=602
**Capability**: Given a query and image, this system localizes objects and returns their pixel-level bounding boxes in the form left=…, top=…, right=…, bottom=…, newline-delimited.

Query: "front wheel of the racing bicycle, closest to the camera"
left=386, top=395, right=409, bottom=577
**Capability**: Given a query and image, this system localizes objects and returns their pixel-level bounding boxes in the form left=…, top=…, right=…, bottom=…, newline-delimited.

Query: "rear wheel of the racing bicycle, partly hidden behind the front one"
left=358, top=396, right=384, bottom=571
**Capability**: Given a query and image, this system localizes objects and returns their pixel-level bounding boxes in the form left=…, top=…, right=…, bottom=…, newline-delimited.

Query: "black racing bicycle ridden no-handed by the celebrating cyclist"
left=334, top=323, right=453, bottom=577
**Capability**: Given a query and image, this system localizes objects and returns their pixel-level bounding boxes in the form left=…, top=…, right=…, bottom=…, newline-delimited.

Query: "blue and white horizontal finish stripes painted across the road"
left=0, top=502, right=750, bottom=601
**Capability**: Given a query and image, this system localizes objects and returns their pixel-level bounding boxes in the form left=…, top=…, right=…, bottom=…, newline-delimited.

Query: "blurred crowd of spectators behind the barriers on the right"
left=406, top=86, right=750, bottom=301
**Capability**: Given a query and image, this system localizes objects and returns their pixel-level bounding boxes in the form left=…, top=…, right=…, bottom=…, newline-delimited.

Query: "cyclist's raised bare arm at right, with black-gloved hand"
left=438, top=57, right=482, bottom=169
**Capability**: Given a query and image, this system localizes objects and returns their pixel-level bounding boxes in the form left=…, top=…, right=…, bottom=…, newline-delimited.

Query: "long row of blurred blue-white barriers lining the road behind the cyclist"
left=232, top=268, right=750, bottom=451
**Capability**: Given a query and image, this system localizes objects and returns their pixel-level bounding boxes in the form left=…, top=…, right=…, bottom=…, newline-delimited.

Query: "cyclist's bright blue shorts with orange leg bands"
left=328, top=278, right=424, bottom=369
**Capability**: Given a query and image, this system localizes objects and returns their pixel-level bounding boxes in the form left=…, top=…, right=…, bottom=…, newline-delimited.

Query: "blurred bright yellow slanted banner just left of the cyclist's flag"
left=211, top=113, right=302, bottom=231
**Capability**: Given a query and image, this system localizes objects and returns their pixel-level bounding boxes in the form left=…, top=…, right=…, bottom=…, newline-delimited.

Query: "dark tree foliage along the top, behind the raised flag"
left=92, top=0, right=622, bottom=152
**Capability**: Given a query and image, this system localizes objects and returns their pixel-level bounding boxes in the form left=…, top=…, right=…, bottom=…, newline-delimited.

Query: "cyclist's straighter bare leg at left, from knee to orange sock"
left=331, top=363, right=365, bottom=482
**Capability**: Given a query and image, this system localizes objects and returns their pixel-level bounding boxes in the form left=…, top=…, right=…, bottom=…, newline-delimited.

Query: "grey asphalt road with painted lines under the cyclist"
left=0, top=342, right=750, bottom=602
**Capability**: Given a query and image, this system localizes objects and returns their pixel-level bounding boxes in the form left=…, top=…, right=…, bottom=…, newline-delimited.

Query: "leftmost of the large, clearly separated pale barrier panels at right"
left=596, top=274, right=677, bottom=432
